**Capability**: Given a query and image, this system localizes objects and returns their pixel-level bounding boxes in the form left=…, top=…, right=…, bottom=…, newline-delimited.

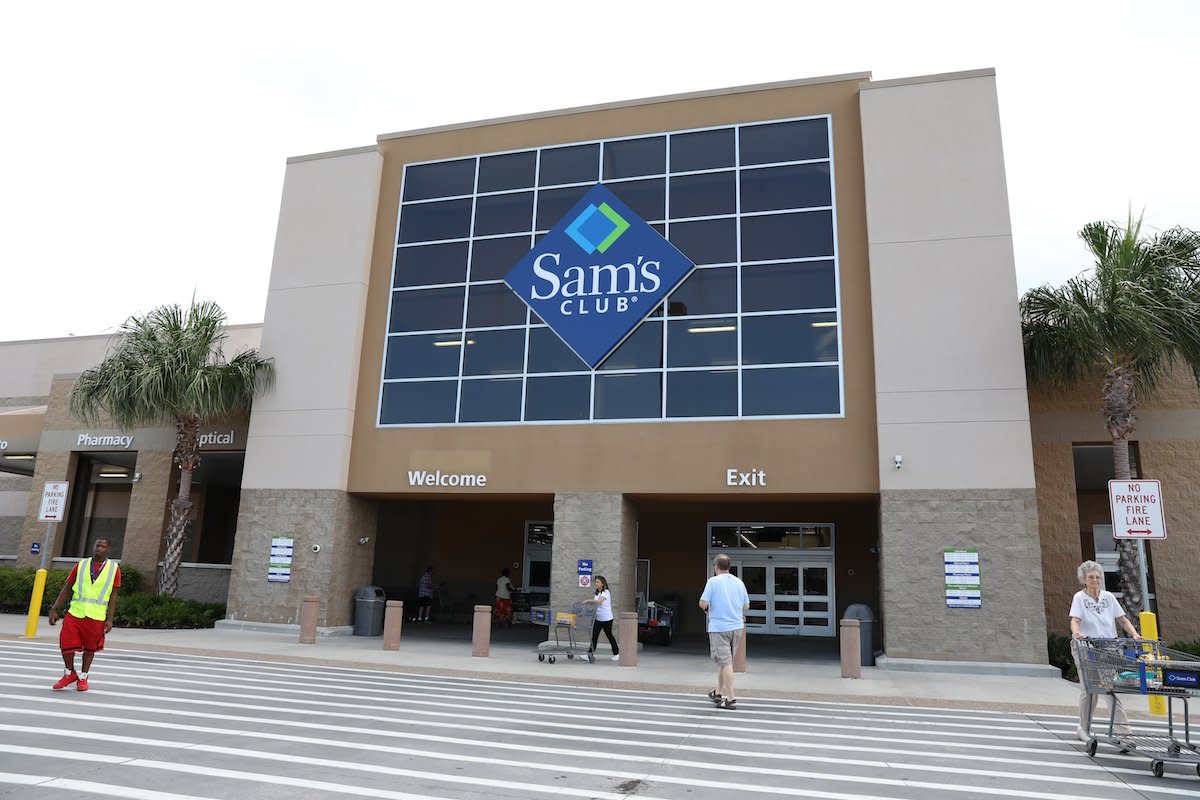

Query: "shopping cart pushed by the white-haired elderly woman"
left=1075, top=639, right=1200, bottom=777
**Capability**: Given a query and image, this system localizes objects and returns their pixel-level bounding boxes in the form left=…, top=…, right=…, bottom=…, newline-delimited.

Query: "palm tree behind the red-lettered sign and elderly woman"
left=1020, top=215, right=1200, bottom=612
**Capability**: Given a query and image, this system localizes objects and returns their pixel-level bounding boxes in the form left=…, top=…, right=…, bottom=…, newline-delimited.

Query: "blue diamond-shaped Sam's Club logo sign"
left=504, top=184, right=695, bottom=368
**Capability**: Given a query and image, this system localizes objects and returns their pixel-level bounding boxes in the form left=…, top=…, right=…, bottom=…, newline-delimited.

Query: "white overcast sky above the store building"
left=0, top=0, right=1200, bottom=341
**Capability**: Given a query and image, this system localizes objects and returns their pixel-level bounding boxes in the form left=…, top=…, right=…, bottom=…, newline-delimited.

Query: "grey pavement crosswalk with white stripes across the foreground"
left=0, top=640, right=1200, bottom=800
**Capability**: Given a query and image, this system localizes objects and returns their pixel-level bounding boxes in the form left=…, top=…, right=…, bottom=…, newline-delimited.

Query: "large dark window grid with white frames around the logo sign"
left=379, top=116, right=844, bottom=426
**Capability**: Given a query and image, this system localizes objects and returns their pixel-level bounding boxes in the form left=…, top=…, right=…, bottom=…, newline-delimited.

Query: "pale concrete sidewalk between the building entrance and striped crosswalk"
left=0, top=614, right=1089, bottom=712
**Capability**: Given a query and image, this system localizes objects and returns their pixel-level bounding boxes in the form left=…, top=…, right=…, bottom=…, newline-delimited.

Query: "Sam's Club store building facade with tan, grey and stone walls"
left=0, top=71, right=1200, bottom=663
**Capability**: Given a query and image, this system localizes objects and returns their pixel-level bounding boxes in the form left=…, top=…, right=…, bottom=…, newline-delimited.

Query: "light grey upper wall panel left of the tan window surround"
left=242, top=148, right=380, bottom=491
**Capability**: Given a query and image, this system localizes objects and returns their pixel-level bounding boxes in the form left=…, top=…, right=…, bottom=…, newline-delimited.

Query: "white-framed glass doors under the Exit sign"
left=709, top=523, right=836, bottom=637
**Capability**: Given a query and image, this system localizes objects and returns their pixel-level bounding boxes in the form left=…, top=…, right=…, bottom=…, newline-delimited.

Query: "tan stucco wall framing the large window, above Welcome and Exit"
left=349, top=77, right=878, bottom=494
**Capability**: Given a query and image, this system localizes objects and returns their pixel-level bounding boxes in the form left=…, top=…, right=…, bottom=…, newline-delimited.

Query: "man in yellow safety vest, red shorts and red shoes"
left=50, top=539, right=121, bottom=692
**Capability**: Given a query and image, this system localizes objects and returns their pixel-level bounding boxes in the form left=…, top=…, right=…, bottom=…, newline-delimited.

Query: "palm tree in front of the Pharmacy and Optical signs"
left=70, top=300, right=275, bottom=595
